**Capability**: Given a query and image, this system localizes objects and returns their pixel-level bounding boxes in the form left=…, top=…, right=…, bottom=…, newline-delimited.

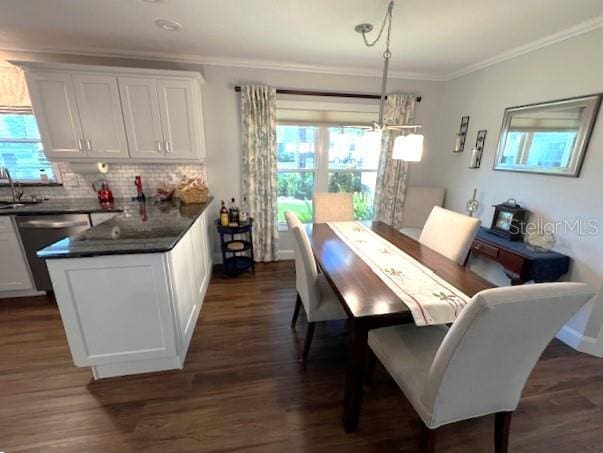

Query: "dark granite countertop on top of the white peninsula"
left=36, top=198, right=212, bottom=259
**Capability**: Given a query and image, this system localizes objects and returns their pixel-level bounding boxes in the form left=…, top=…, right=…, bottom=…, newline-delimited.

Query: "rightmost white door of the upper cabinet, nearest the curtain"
left=157, top=79, right=200, bottom=160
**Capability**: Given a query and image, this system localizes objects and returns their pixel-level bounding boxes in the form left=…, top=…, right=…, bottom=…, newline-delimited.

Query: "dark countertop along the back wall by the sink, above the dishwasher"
left=0, top=198, right=125, bottom=216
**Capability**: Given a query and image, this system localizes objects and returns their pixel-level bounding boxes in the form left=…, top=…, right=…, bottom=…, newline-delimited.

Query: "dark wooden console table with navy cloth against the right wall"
left=471, top=227, right=570, bottom=285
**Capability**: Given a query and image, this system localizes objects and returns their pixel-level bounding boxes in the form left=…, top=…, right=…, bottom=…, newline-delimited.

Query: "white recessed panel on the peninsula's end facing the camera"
left=47, top=253, right=177, bottom=366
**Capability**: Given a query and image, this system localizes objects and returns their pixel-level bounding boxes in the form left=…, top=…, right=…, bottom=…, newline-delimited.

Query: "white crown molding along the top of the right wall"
left=444, top=15, right=603, bottom=80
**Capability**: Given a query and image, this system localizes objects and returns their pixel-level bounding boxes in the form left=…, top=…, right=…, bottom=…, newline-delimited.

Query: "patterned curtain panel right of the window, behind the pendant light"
left=373, top=94, right=416, bottom=229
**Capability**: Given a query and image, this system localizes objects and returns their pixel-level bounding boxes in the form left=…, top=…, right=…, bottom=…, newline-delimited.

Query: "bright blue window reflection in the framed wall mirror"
left=501, top=130, right=576, bottom=168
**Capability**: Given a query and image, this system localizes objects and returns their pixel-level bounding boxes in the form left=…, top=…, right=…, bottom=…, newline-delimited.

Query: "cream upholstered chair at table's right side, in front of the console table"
left=419, top=206, right=480, bottom=264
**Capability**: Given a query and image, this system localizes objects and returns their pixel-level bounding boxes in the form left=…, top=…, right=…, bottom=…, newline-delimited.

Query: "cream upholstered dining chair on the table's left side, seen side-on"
left=285, top=211, right=347, bottom=362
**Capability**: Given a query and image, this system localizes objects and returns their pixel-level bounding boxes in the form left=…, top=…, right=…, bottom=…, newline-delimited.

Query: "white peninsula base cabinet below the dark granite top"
left=46, top=211, right=211, bottom=379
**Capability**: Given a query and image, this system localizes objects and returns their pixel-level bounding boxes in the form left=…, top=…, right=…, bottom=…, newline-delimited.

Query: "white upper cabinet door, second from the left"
left=73, top=74, right=128, bottom=159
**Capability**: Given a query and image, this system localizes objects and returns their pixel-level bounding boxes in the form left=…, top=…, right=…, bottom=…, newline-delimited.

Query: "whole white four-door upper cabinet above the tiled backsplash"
left=12, top=62, right=205, bottom=163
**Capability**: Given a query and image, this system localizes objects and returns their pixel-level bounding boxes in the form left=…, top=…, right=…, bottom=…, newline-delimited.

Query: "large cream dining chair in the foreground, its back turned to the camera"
left=368, top=283, right=594, bottom=453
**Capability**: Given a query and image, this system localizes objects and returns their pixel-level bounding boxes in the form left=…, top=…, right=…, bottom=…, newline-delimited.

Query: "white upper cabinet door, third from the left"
left=118, top=77, right=165, bottom=159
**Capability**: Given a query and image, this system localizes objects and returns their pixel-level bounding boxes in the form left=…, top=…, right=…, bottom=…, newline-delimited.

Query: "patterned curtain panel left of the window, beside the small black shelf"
left=241, top=85, right=278, bottom=261
